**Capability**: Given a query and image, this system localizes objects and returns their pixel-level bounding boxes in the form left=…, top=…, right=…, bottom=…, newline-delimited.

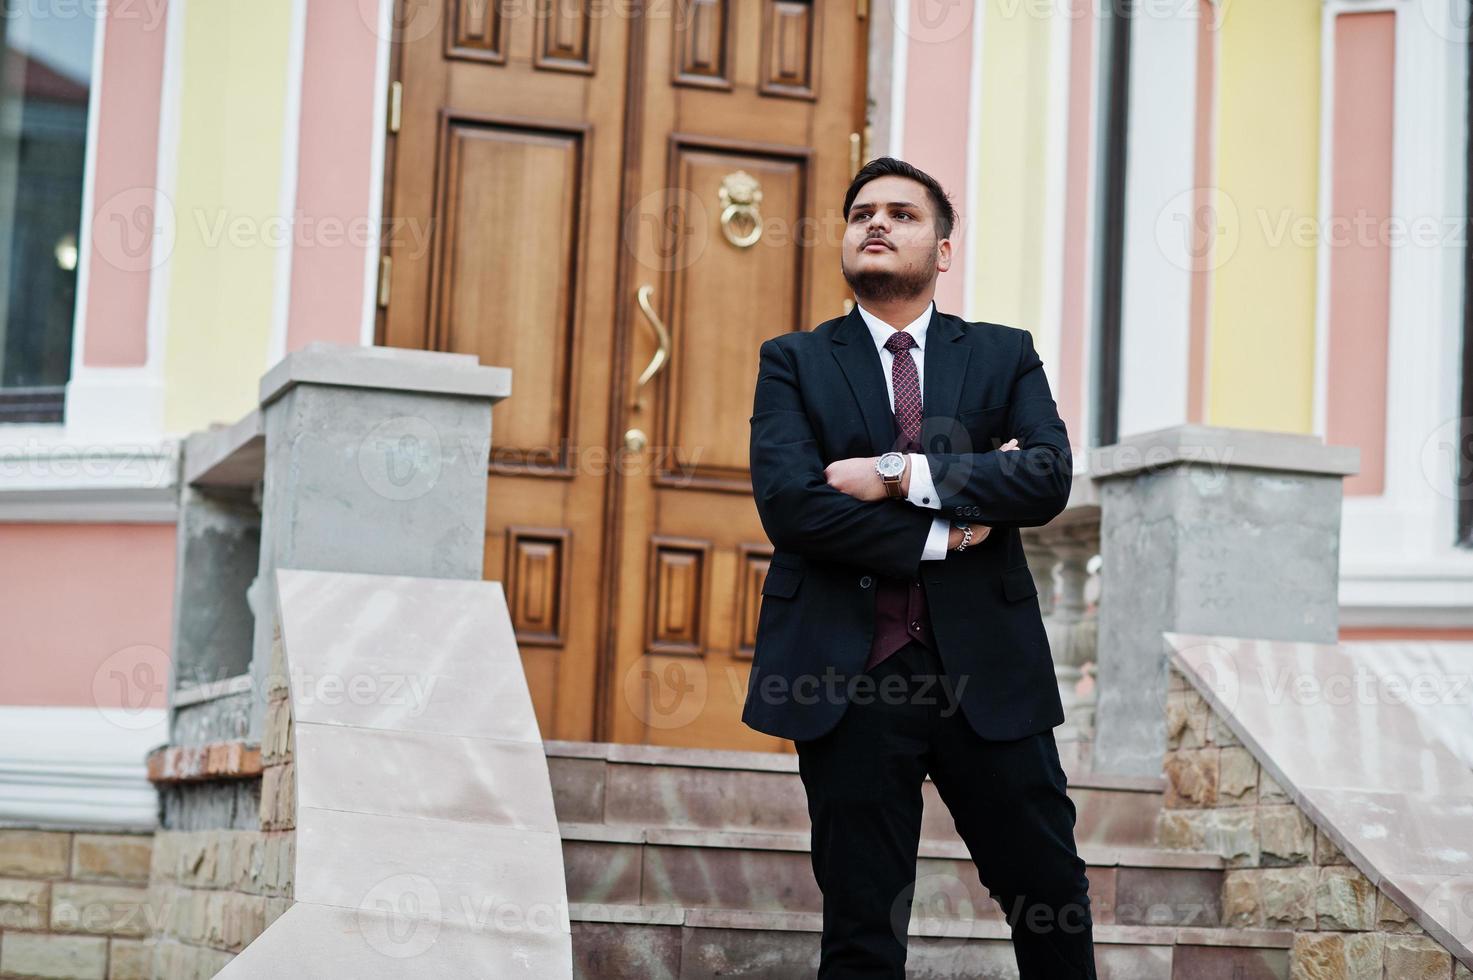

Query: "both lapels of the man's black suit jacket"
left=832, top=305, right=972, bottom=455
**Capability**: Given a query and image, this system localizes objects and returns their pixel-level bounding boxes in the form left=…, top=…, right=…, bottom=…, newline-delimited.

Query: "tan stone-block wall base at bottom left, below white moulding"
left=0, top=830, right=153, bottom=980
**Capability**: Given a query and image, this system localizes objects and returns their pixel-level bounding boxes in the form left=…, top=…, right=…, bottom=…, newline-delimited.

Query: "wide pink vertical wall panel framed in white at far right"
left=1324, top=10, right=1396, bottom=494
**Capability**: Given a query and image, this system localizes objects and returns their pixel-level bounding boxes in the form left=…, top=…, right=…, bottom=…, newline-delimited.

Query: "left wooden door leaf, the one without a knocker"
left=380, top=0, right=630, bottom=740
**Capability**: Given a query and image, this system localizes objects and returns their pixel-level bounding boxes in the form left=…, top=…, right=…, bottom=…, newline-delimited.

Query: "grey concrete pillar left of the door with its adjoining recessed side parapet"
left=169, top=343, right=511, bottom=744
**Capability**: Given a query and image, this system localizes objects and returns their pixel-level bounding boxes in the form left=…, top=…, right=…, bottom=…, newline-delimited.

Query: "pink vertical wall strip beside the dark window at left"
left=82, top=0, right=166, bottom=367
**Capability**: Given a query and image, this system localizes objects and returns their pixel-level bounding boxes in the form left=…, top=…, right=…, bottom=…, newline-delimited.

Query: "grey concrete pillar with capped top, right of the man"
left=1089, top=426, right=1360, bottom=777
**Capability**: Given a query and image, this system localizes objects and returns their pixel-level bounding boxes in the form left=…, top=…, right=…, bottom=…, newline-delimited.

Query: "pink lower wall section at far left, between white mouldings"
left=0, top=525, right=174, bottom=709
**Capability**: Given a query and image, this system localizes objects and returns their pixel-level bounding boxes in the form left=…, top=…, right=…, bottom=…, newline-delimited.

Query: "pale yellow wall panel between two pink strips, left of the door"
left=164, top=0, right=292, bottom=433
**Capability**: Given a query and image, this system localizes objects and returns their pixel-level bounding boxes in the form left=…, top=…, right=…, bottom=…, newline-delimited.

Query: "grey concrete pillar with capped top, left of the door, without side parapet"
left=250, top=343, right=511, bottom=741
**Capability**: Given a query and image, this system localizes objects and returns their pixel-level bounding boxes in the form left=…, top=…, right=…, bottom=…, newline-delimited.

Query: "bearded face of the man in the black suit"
left=840, top=177, right=952, bottom=301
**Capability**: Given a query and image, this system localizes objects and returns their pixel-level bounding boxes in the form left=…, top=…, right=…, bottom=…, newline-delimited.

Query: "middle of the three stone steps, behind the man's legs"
left=560, top=822, right=1223, bottom=927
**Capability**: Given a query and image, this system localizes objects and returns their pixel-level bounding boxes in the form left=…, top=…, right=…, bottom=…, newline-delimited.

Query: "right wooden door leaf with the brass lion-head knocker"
left=611, top=0, right=865, bottom=750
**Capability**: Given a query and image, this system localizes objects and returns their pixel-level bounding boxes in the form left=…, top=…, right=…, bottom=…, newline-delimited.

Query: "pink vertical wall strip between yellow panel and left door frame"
left=287, top=0, right=384, bottom=351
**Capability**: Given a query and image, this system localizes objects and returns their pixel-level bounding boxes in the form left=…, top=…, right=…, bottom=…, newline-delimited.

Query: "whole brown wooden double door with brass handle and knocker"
left=379, top=0, right=868, bottom=750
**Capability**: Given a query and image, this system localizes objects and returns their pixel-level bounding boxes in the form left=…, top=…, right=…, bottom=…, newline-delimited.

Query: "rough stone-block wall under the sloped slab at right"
left=1156, top=666, right=1473, bottom=980
